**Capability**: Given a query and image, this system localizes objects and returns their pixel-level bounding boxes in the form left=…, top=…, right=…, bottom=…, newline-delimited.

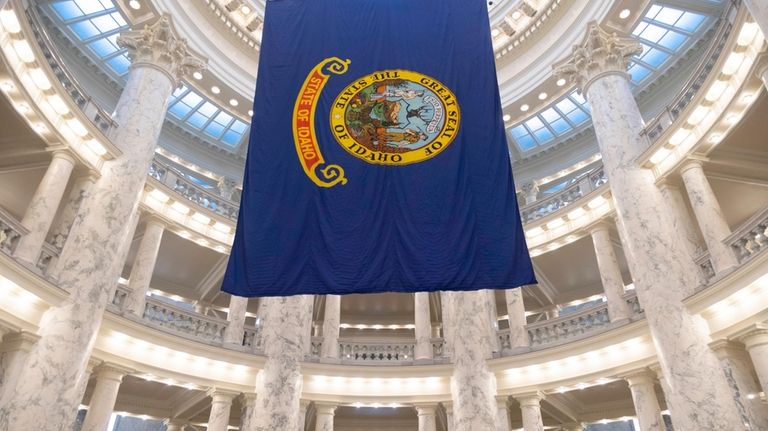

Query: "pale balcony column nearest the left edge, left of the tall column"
left=14, top=151, right=75, bottom=265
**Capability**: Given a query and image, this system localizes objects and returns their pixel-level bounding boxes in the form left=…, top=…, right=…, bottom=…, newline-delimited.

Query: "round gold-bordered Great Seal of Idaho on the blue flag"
left=331, top=70, right=461, bottom=166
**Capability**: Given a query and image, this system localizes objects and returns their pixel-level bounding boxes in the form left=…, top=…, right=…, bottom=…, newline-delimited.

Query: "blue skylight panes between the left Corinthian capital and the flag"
left=168, top=85, right=248, bottom=148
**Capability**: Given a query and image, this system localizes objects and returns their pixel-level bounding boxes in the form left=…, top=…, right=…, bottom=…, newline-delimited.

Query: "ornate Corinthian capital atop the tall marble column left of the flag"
left=117, top=15, right=208, bottom=85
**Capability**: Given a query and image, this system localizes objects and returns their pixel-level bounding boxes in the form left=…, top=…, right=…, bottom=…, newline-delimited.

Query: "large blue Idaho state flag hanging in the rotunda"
left=222, top=0, right=535, bottom=296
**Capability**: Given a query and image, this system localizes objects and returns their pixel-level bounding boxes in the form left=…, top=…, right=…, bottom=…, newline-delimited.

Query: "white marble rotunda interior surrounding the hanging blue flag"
left=0, top=0, right=768, bottom=431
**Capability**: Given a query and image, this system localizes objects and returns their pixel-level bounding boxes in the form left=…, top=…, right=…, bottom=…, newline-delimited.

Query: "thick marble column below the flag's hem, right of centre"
left=444, top=291, right=496, bottom=431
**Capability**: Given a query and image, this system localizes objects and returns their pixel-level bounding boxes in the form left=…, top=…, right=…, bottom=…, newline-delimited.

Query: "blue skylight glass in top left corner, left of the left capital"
left=50, top=0, right=131, bottom=78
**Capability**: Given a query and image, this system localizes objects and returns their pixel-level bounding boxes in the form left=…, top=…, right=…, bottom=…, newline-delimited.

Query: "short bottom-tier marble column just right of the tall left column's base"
left=81, top=364, right=128, bottom=431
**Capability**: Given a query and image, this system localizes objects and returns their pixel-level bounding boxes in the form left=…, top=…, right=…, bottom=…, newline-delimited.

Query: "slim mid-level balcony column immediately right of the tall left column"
left=123, top=217, right=165, bottom=317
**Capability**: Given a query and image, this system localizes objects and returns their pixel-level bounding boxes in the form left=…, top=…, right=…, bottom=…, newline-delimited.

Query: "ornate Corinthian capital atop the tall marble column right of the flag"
left=552, top=21, right=643, bottom=94
